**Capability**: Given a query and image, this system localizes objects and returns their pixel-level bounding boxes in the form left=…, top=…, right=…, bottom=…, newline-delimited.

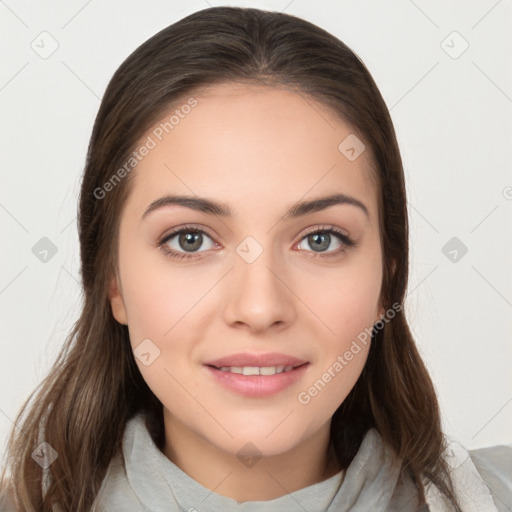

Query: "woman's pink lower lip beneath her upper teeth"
left=204, top=363, right=309, bottom=398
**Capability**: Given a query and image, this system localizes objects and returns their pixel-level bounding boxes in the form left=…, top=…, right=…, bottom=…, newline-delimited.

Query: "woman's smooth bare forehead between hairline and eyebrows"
left=126, top=83, right=377, bottom=218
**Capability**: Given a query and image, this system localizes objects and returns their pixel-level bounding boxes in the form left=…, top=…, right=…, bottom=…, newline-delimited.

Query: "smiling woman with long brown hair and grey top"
left=0, top=7, right=508, bottom=512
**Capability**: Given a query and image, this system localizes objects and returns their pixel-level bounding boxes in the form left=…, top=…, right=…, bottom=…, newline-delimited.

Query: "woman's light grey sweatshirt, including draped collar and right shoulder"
left=0, top=412, right=512, bottom=512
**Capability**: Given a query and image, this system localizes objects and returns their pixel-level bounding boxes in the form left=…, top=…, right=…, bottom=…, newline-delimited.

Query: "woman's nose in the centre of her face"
left=223, top=243, right=297, bottom=333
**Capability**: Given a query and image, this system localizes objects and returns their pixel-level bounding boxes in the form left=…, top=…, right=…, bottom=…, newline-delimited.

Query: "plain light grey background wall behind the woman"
left=0, top=0, right=512, bottom=464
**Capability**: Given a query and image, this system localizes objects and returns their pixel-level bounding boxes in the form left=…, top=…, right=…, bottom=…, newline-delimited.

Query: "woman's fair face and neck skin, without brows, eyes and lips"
left=105, top=83, right=384, bottom=505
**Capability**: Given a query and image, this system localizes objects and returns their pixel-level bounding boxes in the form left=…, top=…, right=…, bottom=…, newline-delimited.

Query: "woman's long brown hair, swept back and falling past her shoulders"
left=2, top=7, right=462, bottom=512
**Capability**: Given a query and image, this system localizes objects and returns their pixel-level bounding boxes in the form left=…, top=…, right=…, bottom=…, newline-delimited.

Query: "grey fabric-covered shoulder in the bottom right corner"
left=468, top=445, right=512, bottom=512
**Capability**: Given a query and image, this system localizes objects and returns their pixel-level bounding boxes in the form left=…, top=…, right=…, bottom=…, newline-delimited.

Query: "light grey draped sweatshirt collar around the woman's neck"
left=123, top=412, right=400, bottom=512
